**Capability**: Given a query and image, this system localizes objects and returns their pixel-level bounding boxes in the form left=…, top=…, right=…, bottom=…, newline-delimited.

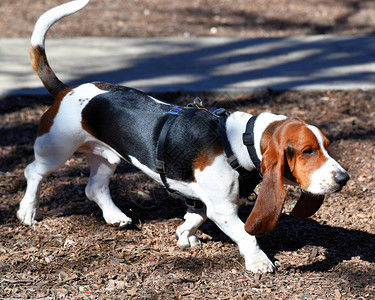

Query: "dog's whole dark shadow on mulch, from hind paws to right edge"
left=0, top=164, right=375, bottom=272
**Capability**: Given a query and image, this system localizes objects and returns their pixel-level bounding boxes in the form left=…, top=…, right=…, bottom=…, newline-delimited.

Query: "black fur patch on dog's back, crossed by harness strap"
left=82, top=85, right=219, bottom=182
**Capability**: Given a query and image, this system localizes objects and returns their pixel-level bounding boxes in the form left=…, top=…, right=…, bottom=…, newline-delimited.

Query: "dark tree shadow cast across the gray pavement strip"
left=66, top=37, right=375, bottom=92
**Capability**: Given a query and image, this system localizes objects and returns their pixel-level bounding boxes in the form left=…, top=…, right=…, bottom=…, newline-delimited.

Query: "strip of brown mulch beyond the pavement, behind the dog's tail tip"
left=0, top=0, right=375, bottom=37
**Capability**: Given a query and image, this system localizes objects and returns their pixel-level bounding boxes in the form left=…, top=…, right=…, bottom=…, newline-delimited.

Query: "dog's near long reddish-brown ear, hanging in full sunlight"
left=245, top=141, right=286, bottom=236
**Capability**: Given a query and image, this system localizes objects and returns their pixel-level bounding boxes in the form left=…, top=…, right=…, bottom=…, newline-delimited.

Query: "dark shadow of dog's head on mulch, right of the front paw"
left=251, top=210, right=375, bottom=272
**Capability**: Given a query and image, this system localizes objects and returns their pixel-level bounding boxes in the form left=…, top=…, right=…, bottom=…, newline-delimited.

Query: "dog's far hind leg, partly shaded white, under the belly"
left=85, top=150, right=132, bottom=227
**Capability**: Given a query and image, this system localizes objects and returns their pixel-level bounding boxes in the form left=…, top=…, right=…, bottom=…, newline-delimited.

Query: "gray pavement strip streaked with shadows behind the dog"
left=0, top=35, right=375, bottom=97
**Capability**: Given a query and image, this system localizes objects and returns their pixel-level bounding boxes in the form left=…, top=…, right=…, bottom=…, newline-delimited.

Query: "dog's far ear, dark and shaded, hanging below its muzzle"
left=292, top=191, right=324, bottom=219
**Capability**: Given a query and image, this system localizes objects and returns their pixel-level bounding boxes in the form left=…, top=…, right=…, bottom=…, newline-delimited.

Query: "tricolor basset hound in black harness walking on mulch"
left=17, top=0, right=349, bottom=272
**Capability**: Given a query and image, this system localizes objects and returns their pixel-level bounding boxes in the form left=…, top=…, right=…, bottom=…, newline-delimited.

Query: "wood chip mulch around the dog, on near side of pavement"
left=0, top=91, right=375, bottom=299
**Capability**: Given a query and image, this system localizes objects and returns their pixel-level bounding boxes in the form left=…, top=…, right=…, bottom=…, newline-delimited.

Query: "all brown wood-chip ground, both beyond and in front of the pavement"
left=0, top=0, right=375, bottom=299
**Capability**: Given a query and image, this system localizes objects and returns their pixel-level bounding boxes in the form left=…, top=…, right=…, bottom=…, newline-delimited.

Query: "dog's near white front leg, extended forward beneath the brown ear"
left=195, top=157, right=275, bottom=273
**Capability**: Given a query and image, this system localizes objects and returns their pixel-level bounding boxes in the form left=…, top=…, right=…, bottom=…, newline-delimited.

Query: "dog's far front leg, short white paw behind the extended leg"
left=176, top=206, right=207, bottom=247
